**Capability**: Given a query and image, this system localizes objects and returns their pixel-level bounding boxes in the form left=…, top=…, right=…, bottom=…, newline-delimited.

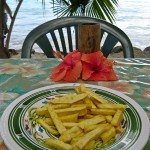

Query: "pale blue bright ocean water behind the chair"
left=7, top=0, right=150, bottom=50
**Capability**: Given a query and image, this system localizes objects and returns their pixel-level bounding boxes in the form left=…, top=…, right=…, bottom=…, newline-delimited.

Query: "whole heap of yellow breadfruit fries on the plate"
left=36, top=84, right=126, bottom=150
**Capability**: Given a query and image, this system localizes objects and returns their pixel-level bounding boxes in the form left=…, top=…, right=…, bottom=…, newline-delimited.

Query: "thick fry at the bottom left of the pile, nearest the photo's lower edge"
left=45, top=138, right=72, bottom=150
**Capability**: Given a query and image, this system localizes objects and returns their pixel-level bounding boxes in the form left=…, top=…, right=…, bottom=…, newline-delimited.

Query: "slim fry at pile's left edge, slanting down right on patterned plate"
left=37, top=119, right=59, bottom=135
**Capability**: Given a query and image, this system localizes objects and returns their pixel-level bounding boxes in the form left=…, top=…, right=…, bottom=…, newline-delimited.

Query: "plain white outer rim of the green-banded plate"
left=0, top=83, right=150, bottom=150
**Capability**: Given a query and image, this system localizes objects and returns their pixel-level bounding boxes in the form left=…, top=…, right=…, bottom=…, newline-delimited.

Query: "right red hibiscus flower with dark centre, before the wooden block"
left=81, top=51, right=118, bottom=81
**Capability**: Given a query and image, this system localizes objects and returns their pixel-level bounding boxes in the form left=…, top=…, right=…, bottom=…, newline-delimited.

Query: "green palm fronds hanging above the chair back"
left=51, top=0, right=118, bottom=23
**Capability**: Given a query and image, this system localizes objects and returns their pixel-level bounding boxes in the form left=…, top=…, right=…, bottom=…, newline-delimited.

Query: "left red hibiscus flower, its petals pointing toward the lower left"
left=50, top=50, right=82, bottom=82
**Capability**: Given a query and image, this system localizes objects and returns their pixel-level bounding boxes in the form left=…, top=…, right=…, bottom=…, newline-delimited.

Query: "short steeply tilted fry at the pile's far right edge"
left=111, top=109, right=123, bottom=126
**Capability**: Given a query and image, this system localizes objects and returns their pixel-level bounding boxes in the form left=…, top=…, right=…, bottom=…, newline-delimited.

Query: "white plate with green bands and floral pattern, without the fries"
left=0, top=83, right=150, bottom=150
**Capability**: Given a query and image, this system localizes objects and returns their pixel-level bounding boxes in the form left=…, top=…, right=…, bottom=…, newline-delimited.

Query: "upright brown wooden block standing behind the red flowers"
left=78, top=23, right=100, bottom=53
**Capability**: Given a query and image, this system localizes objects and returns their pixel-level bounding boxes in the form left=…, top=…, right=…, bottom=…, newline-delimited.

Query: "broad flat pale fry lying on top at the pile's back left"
left=50, top=93, right=87, bottom=104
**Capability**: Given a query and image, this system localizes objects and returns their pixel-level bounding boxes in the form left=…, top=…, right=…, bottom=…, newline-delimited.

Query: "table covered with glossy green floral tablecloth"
left=0, top=58, right=150, bottom=150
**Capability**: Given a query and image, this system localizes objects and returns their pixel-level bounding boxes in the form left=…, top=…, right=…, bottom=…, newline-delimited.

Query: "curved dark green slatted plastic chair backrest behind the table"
left=21, top=16, right=134, bottom=58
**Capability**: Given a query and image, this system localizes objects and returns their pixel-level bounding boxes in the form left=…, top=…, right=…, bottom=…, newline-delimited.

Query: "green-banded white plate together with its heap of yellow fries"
left=0, top=83, right=150, bottom=150
